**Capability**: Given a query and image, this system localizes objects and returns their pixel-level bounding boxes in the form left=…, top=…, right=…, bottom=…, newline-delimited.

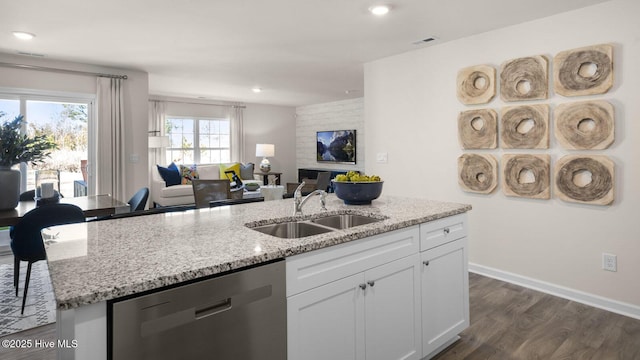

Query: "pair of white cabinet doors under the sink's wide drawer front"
left=287, top=254, right=422, bottom=360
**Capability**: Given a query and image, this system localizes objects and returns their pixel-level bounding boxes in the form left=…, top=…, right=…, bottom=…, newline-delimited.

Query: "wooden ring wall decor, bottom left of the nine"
left=458, top=154, right=498, bottom=194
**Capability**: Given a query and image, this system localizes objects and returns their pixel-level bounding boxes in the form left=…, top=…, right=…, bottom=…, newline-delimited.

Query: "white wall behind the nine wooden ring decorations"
left=365, top=0, right=640, bottom=310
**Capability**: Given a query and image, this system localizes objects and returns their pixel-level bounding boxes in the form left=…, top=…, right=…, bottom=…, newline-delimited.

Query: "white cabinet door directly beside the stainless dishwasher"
left=287, top=273, right=365, bottom=360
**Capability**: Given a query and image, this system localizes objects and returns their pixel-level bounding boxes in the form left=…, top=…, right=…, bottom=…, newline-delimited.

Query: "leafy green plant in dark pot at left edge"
left=0, top=112, right=56, bottom=210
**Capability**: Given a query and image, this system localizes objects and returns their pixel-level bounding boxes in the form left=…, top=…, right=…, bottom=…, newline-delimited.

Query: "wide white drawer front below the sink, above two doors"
left=286, top=225, right=420, bottom=296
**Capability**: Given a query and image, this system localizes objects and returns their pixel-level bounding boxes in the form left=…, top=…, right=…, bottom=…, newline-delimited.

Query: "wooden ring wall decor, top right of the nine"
left=553, top=44, right=613, bottom=96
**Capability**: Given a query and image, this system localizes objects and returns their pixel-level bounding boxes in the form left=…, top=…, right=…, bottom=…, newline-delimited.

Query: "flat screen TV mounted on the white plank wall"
left=317, top=130, right=356, bottom=164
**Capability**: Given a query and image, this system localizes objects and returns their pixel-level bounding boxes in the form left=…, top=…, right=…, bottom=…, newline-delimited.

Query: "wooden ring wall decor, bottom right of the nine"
left=554, top=155, right=615, bottom=205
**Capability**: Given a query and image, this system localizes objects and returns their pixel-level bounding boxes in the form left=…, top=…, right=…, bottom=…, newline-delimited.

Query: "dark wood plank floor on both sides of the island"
left=0, top=274, right=640, bottom=360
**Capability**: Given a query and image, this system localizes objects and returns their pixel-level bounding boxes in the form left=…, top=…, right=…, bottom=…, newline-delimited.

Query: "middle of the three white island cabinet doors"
left=368, top=253, right=422, bottom=360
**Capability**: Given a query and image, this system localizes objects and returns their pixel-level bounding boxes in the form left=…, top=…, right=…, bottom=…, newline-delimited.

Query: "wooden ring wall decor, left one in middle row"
left=458, top=109, right=498, bottom=149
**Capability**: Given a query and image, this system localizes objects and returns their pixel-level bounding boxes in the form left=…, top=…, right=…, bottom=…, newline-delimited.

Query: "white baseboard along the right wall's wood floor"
left=469, top=263, right=640, bottom=320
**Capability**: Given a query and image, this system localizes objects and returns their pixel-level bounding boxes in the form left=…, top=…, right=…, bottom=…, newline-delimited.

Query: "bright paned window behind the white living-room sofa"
left=165, top=116, right=231, bottom=164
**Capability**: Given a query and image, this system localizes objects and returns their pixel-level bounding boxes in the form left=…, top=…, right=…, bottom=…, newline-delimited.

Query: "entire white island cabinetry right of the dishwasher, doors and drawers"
left=286, top=214, right=469, bottom=360
